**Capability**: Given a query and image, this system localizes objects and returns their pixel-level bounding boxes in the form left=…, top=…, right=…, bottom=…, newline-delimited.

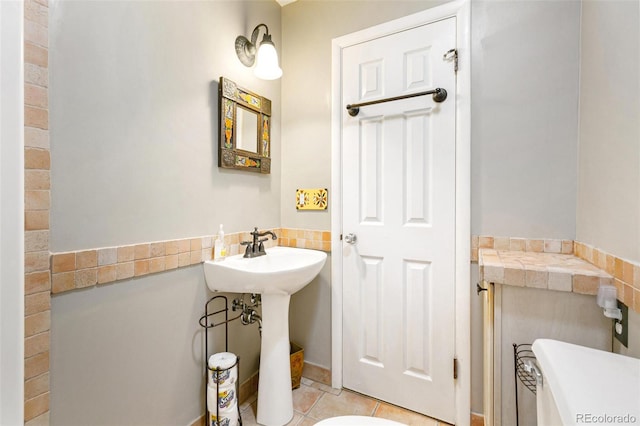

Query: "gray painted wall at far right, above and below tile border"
left=576, top=1, right=640, bottom=357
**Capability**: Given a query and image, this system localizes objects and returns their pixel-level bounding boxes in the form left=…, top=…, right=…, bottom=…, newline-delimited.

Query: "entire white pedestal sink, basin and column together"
left=204, top=247, right=327, bottom=426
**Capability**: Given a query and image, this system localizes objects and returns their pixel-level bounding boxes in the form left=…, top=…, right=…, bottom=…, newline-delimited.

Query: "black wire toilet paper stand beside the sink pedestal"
left=199, top=296, right=242, bottom=426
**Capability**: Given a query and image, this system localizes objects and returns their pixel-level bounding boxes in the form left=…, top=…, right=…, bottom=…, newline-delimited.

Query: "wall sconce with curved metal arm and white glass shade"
left=236, top=24, right=282, bottom=80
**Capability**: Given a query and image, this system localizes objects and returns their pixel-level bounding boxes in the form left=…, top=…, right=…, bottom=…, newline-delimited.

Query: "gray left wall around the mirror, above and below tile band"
left=49, top=1, right=281, bottom=425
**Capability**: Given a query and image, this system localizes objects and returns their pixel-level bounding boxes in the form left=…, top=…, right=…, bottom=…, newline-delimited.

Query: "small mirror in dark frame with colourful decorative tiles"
left=218, top=77, right=271, bottom=173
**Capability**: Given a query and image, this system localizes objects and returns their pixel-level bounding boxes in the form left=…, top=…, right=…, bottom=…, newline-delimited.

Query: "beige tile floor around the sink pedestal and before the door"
left=240, top=377, right=448, bottom=426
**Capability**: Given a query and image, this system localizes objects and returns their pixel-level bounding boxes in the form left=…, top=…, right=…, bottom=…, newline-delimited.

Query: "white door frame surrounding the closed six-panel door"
left=331, top=0, right=471, bottom=425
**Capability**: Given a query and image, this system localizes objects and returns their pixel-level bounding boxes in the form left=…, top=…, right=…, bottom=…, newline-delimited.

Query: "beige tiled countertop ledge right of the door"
left=478, top=249, right=613, bottom=295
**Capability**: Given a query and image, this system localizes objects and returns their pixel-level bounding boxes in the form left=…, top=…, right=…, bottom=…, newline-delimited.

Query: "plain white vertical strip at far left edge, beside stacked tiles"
left=0, top=0, right=24, bottom=424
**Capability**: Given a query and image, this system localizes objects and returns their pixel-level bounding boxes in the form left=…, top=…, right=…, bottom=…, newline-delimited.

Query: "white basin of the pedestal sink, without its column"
left=204, top=247, right=327, bottom=294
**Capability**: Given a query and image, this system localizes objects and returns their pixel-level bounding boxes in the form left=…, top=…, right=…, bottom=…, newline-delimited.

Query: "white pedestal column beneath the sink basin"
left=256, top=293, right=293, bottom=426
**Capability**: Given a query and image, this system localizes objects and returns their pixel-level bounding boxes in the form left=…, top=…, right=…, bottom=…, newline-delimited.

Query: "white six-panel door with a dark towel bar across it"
left=342, top=18, right=456, bottom=422
